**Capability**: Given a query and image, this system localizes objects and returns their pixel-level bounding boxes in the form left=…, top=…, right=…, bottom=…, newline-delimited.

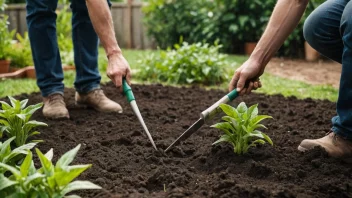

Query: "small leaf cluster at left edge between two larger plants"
left=0, top=137, right=37, bottom=173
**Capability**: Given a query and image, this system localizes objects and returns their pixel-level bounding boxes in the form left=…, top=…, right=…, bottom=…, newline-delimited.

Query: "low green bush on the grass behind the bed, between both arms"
left=138, top=42, right=227, bottom=84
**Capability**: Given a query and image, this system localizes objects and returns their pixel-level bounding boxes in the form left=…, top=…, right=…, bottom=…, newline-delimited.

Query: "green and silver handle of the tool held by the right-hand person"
left=200, top=89, right=238, bottom=121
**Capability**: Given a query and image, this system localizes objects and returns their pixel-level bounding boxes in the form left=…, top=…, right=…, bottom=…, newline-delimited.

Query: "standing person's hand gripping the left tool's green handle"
left=106, top=54, right=131, bottom=92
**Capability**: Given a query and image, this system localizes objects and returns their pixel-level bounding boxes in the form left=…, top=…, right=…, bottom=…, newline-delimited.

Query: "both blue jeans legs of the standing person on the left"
left=26, top=0, right=110, bottom=97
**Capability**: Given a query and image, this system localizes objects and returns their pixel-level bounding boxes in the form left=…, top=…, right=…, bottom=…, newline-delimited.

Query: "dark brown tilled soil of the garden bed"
left=17, top=84, right=352, bottom=198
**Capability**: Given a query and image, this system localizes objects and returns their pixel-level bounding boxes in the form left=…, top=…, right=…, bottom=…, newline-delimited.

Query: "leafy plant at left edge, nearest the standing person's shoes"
left=0, top=96, right=47, bottom=146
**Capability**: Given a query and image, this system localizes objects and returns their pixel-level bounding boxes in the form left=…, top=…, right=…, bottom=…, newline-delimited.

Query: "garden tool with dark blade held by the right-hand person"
left=165, top=89, right=238, bottom=152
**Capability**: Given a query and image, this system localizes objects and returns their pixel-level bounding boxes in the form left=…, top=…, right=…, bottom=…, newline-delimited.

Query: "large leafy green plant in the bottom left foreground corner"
left=0, top=145, right=101, bottom=198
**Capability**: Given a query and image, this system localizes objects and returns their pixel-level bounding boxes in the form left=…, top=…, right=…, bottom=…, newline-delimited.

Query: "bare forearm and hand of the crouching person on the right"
left=229, top=0, right=308, bottom=95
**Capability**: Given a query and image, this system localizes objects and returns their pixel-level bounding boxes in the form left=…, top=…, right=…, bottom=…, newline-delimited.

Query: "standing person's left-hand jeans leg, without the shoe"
left=26, top=0, right=64, bottom=97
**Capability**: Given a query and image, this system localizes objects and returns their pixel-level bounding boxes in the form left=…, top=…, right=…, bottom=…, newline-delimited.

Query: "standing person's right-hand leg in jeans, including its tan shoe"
left=71, top=0, right=122, bottom=113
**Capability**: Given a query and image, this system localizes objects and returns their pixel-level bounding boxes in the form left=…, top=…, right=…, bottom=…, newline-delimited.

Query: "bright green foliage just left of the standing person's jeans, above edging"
left=10, top=32, right=34, bottom=68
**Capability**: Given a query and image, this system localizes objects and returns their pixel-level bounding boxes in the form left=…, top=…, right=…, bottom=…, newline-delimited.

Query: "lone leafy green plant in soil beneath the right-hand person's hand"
left=212, top=102, right=273, bottom=155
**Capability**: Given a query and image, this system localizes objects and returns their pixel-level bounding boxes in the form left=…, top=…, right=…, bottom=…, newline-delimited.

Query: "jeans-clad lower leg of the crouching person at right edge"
left=332, top=1, right=352, bottom=140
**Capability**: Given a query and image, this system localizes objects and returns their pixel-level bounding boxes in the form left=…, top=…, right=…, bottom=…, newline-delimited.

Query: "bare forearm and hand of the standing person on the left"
left=86, top=0, right=131, bottom=91
